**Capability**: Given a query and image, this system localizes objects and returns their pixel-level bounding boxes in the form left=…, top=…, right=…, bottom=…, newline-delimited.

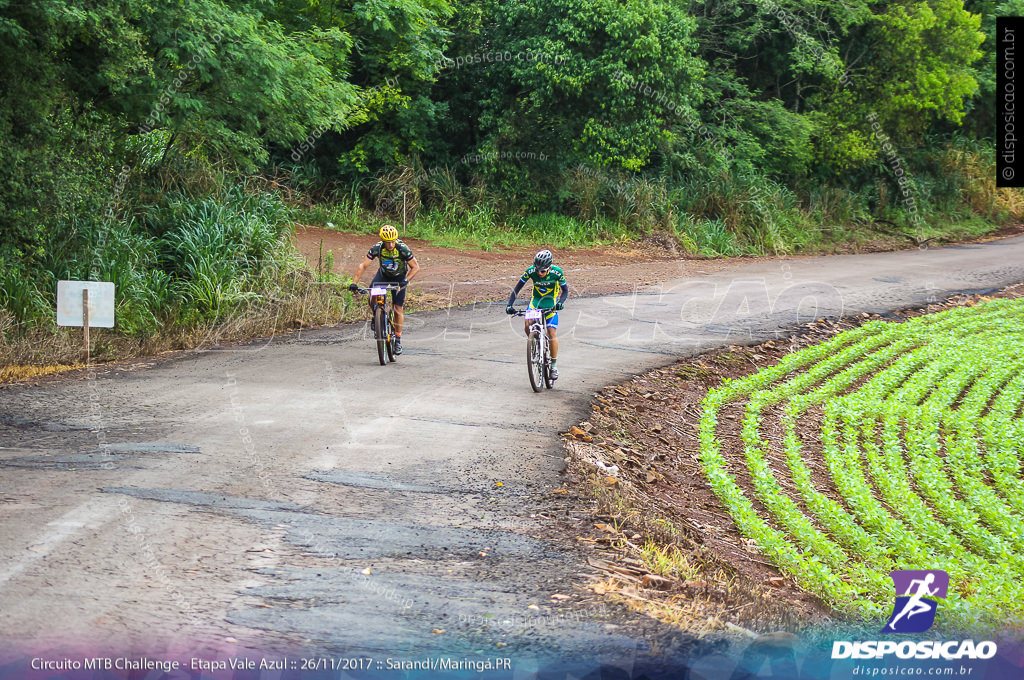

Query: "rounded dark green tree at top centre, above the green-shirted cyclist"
left=450, top=0, right=702, bottom=198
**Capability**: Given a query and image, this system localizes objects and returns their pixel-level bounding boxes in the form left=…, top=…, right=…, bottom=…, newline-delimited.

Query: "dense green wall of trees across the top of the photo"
left=0, top=0, right=1007, bottom=329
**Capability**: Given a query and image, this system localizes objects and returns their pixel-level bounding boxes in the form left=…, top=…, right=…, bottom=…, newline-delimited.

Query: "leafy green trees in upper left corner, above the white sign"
left=0, top=0, right=357, bottom=274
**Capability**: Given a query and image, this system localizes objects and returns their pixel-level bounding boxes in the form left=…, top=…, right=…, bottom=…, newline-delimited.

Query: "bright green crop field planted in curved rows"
left=699, top=300, right=1024, bottom=627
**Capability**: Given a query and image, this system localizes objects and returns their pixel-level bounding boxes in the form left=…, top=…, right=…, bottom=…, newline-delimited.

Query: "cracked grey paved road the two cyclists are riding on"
left=0, top=238, right=1024, bottom=658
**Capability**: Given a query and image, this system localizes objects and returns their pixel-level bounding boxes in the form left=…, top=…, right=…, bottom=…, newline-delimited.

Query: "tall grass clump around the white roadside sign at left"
left=0, top=184, right=307, bottom=363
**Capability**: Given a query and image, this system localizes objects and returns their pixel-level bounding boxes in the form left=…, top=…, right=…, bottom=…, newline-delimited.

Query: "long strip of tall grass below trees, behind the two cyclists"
left=302, top=139, right=1024, bottom=256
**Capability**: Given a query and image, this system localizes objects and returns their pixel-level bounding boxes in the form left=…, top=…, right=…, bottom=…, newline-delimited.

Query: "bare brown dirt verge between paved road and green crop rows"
left=565, top=284, right=1024, bottom=631
